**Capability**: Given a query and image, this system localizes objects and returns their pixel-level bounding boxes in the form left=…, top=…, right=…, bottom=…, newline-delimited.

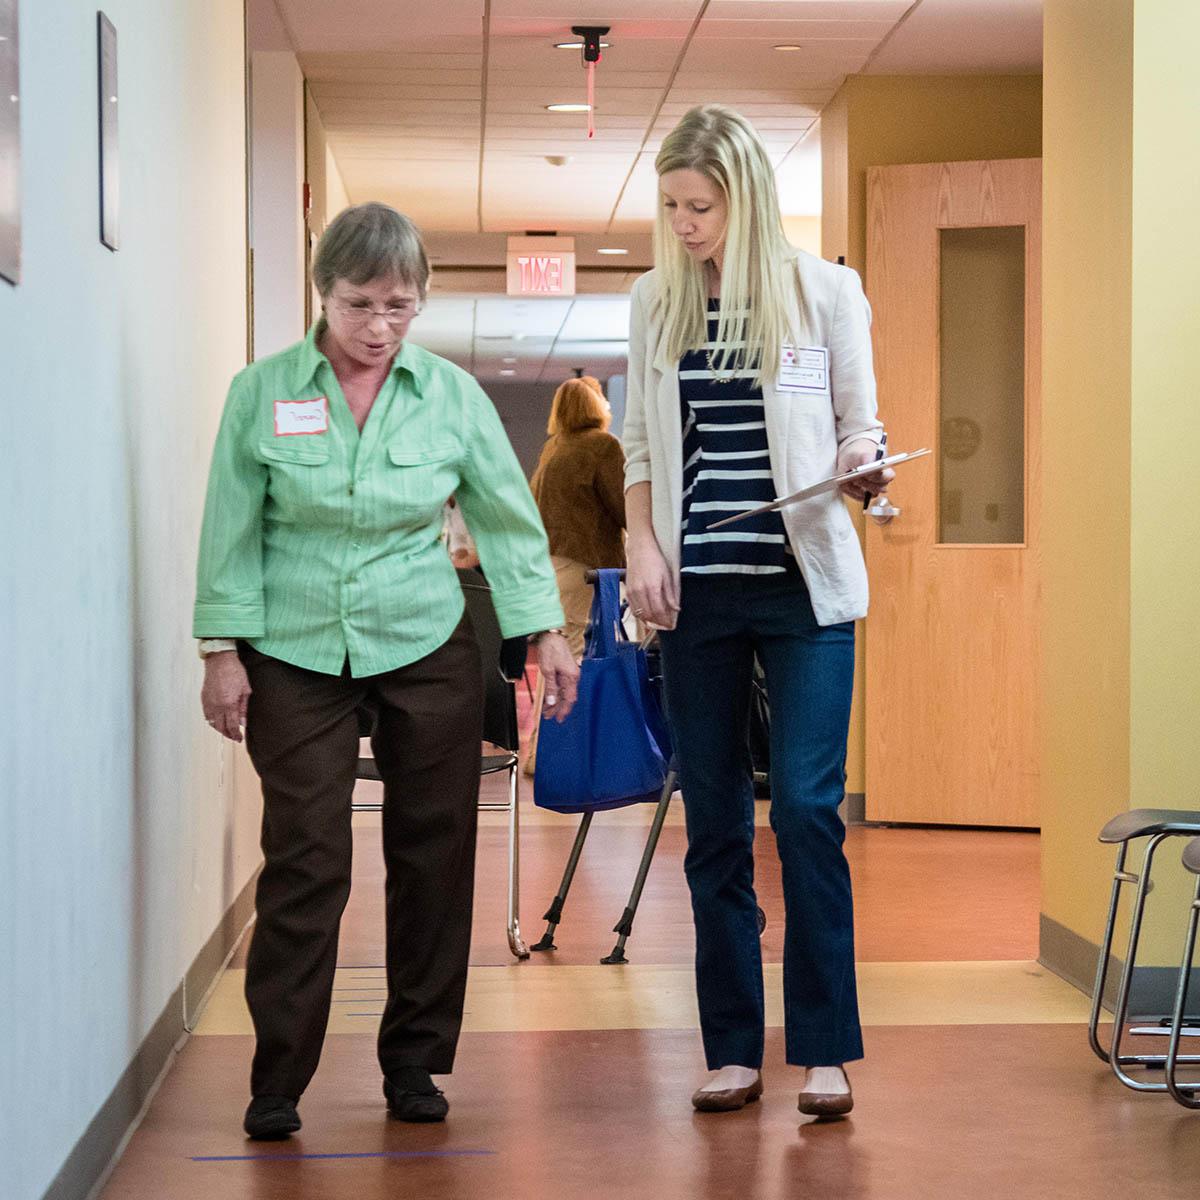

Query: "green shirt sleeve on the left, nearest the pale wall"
left=192, top=377, right=268, bottom=638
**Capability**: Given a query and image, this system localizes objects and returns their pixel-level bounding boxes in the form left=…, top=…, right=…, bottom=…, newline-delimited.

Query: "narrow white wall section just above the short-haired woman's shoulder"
left=251, top=50, right=307, bottom=359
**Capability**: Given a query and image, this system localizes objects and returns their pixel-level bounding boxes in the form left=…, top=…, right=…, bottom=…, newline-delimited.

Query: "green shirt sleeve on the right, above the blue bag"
left=456, top=384, right=564, bottom=637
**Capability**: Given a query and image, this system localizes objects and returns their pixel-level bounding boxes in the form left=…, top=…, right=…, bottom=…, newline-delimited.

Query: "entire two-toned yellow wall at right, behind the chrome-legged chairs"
left=1042, top=0, right=1200, bottom=964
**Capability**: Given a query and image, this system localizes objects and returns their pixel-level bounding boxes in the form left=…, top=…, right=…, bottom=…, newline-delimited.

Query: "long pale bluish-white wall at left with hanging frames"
left=0, top=0, right=258, bottom=1200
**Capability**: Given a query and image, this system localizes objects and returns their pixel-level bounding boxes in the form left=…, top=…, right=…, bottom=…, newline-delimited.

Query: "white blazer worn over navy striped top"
left=622, top=251, right=883, bottom=625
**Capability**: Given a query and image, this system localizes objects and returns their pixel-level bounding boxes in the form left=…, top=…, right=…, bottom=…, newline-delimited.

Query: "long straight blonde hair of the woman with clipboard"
left=654, top=104, right=803, bottom=386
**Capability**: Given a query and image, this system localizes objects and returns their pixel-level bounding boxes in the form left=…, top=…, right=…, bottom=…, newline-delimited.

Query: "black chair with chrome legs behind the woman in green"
left=352, top=568, right=529, bottom=959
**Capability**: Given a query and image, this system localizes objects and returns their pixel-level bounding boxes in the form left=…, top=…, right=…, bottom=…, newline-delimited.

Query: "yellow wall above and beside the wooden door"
left=821, top=76, right=1042, bottom=792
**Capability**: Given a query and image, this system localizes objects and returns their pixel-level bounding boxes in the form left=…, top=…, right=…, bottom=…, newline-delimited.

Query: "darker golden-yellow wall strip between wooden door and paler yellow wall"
left=1040, top=0, right=1133, bottom=942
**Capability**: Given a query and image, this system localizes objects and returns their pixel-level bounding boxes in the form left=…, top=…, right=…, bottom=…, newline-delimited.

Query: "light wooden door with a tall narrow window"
left=865, top=158, right=1042, bottom=826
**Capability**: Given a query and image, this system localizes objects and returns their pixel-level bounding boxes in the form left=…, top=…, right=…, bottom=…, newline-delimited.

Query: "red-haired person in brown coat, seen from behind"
left=526, top=378, right=625, bottom=775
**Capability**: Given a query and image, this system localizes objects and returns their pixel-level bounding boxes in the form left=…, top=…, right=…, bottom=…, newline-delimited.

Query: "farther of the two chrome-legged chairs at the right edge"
left=1087, top=809, right=1200, bottom=1092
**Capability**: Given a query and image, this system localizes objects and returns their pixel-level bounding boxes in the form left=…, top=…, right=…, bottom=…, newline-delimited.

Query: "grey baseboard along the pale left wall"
left=42, top=872, right=258, bottom=1200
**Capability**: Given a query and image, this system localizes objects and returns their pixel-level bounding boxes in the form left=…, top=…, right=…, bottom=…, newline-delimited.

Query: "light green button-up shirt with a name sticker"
left=192, top=326, right=563, bottom=676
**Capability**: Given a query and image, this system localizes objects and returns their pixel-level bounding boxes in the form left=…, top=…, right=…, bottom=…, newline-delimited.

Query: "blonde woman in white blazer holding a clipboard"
left=624, top=104, right=892, bottom=1116
